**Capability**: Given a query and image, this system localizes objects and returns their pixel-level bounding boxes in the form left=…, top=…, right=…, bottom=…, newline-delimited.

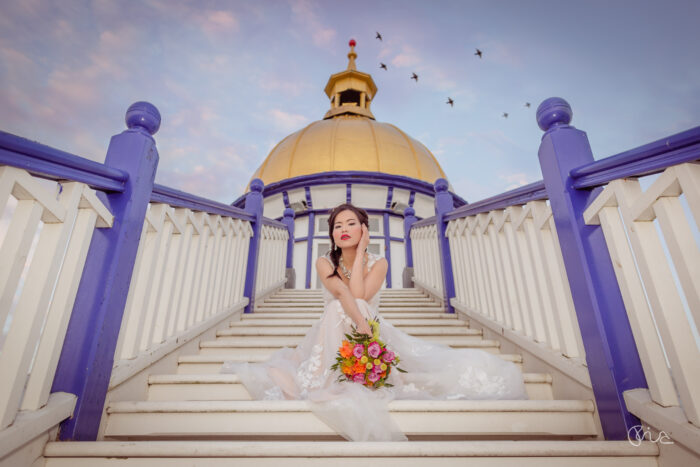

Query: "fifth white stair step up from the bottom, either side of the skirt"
left=199, top=336, right=501, bottom=355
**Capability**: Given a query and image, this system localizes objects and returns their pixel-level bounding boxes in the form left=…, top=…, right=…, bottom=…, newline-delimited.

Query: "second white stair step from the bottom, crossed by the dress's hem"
left=104, top=400, right=596, bottom=440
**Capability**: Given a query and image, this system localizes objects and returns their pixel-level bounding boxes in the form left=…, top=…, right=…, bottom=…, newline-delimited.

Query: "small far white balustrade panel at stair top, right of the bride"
left=411, top=224, right=443, bottom=299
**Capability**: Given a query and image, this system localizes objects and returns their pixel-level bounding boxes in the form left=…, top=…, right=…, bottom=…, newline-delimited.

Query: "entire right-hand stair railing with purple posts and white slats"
left=410, top=98, right=700, bottom=453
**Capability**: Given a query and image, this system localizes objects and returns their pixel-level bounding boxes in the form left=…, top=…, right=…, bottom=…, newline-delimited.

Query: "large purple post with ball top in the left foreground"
left=51, top=102, right=160, bottom=441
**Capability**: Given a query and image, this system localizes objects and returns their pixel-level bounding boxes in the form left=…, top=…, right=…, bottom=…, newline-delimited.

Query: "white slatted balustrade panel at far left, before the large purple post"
left=0, top=166, right=113, bottom=429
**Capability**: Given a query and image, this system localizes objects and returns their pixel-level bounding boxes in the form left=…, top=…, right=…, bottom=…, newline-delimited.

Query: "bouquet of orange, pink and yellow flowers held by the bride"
left=331, top=320, right=406, bottom=389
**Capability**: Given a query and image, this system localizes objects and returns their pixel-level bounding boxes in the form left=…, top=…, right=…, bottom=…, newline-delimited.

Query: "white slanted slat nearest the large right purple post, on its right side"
left=598, top=207, right=678, bottom=407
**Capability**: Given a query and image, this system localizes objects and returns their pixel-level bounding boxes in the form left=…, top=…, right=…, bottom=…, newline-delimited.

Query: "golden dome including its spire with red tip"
left=252, top=41, right=446, bottom=185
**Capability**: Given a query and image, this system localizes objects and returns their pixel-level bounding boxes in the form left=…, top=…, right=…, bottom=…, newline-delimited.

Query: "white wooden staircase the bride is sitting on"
left=41, top=289, right=659, bottom=467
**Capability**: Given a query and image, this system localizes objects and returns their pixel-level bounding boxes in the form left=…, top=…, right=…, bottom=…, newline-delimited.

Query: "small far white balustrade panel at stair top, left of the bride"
left=255, top=224, right=289, bottom=299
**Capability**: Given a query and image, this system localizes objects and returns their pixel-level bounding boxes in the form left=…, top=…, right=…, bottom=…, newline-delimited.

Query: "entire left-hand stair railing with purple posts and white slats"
left=0, top=103, right=288, bottom=446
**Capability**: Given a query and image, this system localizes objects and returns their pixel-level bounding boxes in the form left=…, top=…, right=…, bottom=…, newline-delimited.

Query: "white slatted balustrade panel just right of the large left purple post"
left=110, top=203, right=256, bottom=387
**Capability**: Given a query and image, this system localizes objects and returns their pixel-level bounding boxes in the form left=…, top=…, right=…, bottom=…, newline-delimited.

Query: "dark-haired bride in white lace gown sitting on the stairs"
left=221, top=204, right=528, bottom=441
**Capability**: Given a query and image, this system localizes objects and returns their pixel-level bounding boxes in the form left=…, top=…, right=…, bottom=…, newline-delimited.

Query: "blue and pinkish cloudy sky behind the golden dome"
left=0, top=0, right=700, bottom=203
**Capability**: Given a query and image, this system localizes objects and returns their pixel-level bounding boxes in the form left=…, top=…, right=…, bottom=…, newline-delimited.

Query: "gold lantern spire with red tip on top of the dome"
left=323, top=39, right=377, bottom=120
